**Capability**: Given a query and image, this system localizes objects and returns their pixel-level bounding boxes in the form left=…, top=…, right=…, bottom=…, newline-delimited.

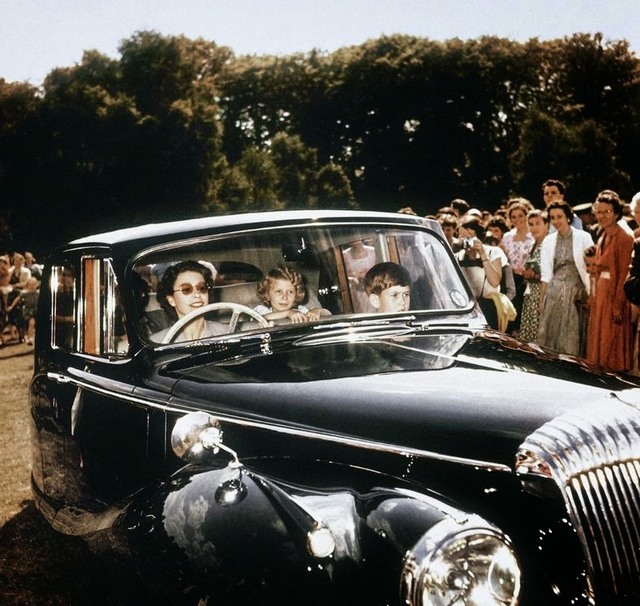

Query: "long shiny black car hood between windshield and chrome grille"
left=166, top=332, right=640, bottom=467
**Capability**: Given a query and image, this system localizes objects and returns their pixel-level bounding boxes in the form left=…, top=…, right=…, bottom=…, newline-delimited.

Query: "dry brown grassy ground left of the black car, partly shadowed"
left=0, top=344, right=100, bottom=606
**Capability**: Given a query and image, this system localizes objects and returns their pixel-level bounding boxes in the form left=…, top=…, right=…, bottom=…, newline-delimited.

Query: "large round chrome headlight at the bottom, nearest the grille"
left=402, top=516, right=520, bottom=606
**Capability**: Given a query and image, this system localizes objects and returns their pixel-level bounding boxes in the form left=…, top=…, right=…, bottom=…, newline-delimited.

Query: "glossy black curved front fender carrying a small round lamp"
left=115, top=465, right=465, bottom=604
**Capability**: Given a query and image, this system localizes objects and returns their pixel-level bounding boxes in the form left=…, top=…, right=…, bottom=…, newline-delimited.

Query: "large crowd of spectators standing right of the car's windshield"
left=428, top=179, right=640, bottom=373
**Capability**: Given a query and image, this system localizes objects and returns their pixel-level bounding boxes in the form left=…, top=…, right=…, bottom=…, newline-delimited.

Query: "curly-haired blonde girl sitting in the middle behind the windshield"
left=254, top=266, right=328, bottom=324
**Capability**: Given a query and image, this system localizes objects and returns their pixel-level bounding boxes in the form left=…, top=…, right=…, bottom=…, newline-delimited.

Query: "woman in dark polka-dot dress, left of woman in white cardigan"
left=519, top=210, right=549, bottom=343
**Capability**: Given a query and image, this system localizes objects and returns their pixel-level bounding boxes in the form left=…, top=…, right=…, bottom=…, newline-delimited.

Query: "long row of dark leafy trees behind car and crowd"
left=0, top=31, right=640, bottom=250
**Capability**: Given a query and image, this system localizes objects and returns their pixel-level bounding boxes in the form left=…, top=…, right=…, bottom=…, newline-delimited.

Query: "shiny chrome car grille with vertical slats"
left=521, top=399, right=640, bottom=605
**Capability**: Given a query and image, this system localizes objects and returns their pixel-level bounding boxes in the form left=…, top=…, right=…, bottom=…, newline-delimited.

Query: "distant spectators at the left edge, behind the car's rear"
left=0, top=252, right=42, bottom=346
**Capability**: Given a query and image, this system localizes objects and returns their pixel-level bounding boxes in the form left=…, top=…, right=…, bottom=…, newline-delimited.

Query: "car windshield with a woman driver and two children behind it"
left=131, top=225, right=472, bottom=344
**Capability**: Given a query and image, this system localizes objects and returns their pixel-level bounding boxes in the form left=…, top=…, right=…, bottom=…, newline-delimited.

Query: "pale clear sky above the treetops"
left=0, top=0, right=640, bottom=86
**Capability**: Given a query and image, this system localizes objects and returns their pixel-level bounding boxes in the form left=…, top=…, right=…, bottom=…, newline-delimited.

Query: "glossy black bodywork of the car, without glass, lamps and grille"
left=31, top=213, right=638, bottom=606
